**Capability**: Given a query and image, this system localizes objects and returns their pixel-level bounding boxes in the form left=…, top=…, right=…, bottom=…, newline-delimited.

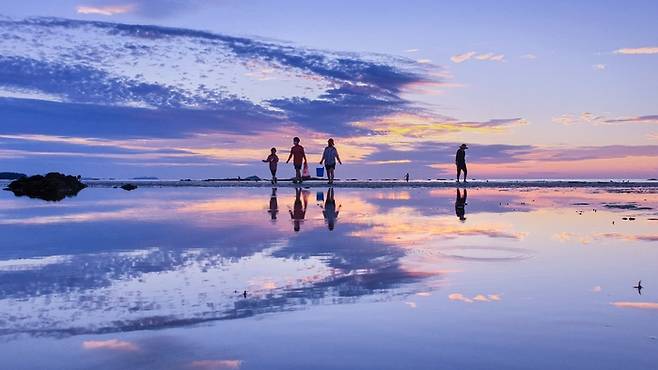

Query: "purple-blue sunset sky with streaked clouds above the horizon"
left=0, top=0, right=658, bottom=179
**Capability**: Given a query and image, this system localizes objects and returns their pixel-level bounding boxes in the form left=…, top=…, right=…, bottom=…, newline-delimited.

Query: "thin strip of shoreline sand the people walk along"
left=78, top=180, right=658, bottom=189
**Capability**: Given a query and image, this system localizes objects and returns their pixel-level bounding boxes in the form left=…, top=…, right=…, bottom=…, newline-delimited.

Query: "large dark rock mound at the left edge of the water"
left=6, top=172, right=87, bottom=201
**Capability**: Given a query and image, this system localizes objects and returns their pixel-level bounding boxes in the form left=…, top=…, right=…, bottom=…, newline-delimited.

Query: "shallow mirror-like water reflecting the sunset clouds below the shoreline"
left=0, top=188, right=658, bottom=369
